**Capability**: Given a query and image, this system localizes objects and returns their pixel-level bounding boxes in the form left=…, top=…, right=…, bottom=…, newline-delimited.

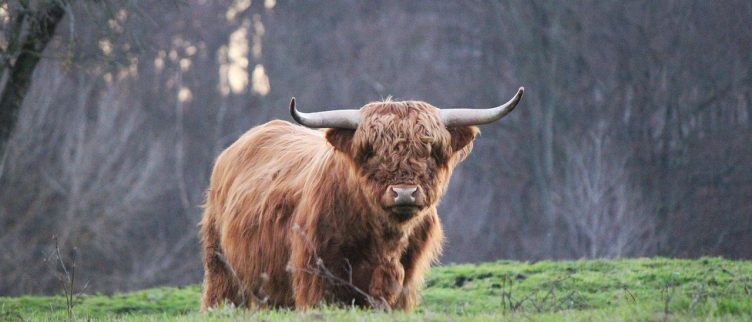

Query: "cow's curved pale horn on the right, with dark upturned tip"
left=440, top=87, right=525, bottom=127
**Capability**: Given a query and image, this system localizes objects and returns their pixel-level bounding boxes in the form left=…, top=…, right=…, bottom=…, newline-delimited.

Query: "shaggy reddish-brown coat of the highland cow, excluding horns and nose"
left=201, top=101, right=478, bottom=310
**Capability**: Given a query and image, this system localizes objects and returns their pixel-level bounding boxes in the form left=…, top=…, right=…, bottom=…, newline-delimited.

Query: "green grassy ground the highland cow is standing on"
left=0, top=258, right=752, bottom=321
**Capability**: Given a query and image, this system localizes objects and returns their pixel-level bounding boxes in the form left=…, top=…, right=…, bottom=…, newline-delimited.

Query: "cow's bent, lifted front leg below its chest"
left=368, top=259, right=405, bottom=307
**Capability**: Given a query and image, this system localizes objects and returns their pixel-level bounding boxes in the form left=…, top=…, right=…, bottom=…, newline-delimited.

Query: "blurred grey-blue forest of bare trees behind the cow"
left=0, top=0, right=752, bottom=295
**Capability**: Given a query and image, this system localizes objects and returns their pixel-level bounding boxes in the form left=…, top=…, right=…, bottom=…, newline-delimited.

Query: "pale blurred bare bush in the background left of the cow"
left=0, top=65, right=175, bottom=289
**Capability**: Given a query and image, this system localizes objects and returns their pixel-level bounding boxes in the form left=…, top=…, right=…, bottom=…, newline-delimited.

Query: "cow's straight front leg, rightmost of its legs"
left=392, top=211, right=444, bottom=311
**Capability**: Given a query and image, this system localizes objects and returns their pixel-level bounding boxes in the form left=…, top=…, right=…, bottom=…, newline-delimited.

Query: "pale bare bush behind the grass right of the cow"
left=554, top=123, right=656, bottom=258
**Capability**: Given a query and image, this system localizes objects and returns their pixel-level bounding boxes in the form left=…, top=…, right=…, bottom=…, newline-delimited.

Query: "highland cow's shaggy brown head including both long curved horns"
left=290, top=88, right=523, bottom=222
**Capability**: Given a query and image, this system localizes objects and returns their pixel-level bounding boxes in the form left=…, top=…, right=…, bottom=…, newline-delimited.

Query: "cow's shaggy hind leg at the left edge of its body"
left=201, top=210, right=240, bottom=311
